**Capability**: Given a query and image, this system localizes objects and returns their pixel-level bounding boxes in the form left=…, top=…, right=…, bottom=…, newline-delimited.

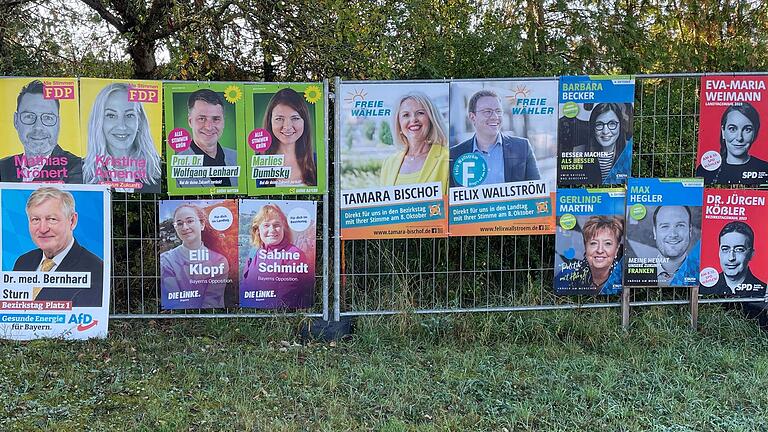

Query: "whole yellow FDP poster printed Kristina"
left=80, top=78, right=163, bottom=193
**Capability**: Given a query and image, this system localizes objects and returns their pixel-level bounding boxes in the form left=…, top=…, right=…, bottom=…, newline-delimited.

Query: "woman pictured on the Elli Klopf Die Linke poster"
left=160, top=204, right=229, bottom=309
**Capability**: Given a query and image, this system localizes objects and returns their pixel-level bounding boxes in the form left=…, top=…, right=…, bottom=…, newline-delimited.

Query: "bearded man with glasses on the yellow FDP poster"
left=0, top=80, right=83, bottom=184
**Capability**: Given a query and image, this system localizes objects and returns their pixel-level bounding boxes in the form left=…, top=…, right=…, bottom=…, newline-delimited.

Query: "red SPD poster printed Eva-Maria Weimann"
left=696, top=75, right=768, bottom=186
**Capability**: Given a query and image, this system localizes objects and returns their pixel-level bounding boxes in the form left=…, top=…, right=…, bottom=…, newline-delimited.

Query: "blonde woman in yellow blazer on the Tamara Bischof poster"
left=380, top=92, right=449, bottom=194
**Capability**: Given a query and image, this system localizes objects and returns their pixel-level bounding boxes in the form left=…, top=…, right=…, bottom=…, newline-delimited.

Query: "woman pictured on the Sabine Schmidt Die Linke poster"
left=240, top=204, right=315, bottom=308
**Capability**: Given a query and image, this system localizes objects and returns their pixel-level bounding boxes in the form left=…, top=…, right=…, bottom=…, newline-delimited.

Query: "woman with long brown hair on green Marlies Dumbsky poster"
left=259, top=88, right=317, bottom=186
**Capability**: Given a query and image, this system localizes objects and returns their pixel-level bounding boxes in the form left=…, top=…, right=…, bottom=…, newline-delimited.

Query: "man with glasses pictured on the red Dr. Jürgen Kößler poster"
left=701, top=221, right=765, bottom=297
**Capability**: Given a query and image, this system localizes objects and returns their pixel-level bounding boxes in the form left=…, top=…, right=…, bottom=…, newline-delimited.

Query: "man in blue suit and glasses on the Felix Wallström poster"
left=450, top=90, right=541, bottom=187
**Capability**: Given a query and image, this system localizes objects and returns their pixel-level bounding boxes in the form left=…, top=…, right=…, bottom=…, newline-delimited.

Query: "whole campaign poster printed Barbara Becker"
left=558, top=75, right=635, bottom=186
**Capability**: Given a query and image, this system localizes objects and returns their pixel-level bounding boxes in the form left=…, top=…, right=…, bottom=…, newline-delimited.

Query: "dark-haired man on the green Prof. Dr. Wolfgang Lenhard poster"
left=176, top=89, right=237, bottom=187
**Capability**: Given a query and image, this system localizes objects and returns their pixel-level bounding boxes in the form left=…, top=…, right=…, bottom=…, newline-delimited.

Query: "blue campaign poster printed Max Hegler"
left=624, top=178, right=704, bottom=287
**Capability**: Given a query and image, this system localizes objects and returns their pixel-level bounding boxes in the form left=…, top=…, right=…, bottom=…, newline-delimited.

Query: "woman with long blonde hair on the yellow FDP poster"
left=83, top=83, right=161, bottom=193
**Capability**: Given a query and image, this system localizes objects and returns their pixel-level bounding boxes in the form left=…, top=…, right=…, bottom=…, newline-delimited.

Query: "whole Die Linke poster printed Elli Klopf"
left=158, top=199, right=238, bottom=310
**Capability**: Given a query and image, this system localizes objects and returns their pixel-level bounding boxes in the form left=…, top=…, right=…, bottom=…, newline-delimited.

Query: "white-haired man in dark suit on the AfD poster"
left=12, top=186, right=104, bottom=307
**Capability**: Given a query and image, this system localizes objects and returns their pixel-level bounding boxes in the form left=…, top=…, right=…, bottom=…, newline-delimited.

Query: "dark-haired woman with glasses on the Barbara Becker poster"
left=584, top=103, right=632, bottom=184
